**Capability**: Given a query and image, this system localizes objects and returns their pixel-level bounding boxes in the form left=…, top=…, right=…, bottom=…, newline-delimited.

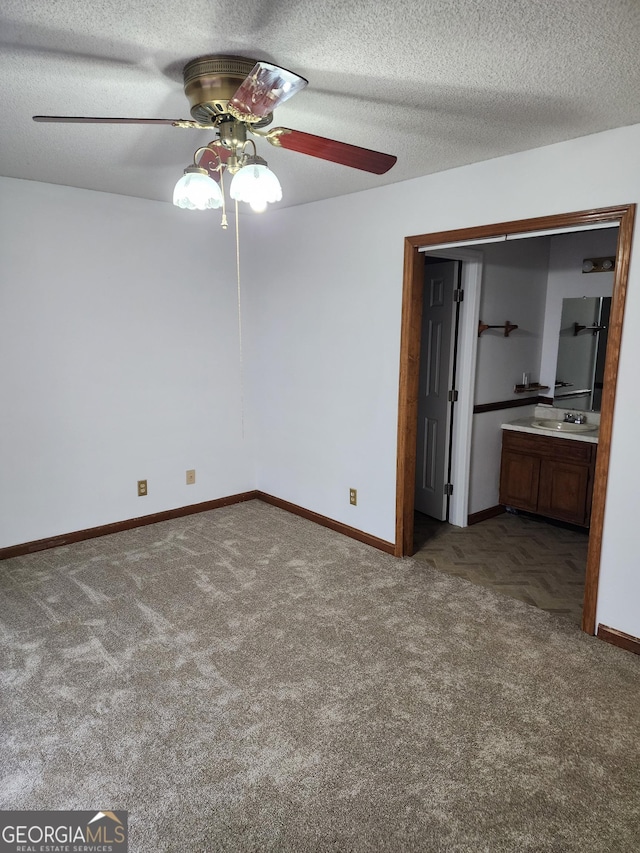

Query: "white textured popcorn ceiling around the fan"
left=0, top=0, right=640, bottom=206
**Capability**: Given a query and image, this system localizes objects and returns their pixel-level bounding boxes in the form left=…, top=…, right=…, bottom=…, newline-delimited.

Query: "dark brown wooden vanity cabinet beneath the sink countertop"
left=500, top=430, right=598, bottom=527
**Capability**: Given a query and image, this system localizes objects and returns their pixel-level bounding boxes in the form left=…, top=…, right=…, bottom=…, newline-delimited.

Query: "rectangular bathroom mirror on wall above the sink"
left=553, top=296, right=611, bottom=412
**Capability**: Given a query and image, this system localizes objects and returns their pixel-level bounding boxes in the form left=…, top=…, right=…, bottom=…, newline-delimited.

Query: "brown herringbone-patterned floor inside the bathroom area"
left=414, top=512, right=589, bottom=624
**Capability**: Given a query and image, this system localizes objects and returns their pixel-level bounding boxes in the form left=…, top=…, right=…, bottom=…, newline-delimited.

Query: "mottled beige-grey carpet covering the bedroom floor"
left=0, top=501, right=640, bottom=853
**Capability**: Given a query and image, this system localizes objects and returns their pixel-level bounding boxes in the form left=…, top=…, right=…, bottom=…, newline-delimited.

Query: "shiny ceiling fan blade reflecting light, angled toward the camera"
left=229, top=62, right=309, bottom=121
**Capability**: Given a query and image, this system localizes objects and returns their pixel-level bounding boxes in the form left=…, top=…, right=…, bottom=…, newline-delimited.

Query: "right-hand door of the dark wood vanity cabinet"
left=538, top=459, right=591, bottom=526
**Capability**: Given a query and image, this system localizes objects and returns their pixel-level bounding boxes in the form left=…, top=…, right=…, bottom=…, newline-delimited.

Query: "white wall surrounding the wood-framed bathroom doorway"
left=251, top=125, right=640, bottom=636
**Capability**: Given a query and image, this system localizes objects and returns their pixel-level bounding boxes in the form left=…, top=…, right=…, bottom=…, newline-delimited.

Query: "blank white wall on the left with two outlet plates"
left=0, top=178, right=254, bottom=547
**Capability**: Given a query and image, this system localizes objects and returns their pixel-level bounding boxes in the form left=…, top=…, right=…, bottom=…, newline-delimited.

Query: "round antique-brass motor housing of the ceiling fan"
left=183, top=56, right=271, bottom=125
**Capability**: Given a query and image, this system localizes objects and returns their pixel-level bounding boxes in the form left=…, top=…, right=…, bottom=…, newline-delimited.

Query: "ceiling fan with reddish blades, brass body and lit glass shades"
left=33, top=55, right=397, bottom=216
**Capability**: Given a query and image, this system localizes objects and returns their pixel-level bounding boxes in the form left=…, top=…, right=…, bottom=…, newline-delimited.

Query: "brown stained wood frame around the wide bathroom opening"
left=395, top=204, right=636, bottom=634
